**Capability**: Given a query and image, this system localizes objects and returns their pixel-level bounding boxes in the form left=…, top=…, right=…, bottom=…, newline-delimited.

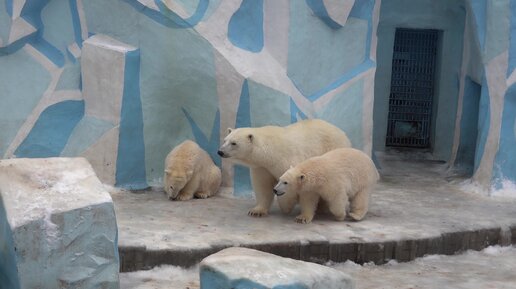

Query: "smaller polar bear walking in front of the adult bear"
left=274, top=148, right=379, bottom=223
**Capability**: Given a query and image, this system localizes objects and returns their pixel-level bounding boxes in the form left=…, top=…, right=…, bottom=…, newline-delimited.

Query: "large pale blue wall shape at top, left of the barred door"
left=287, top=0, right=368, bottom=101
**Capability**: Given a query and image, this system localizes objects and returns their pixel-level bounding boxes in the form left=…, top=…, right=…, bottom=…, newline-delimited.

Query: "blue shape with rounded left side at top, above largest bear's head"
left=228, top=0, right=263, bottom=52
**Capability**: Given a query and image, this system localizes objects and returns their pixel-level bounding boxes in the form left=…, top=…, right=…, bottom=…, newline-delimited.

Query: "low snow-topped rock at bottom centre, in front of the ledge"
left=199, top=247, right=355, bottom=289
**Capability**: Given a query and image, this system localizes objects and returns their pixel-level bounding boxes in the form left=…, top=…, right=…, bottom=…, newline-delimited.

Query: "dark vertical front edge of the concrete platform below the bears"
left=119, top=226, right=516, bottom=272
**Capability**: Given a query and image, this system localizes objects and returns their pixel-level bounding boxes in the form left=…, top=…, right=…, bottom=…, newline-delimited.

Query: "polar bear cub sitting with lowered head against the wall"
left=163, top=140, right=221, bottom=201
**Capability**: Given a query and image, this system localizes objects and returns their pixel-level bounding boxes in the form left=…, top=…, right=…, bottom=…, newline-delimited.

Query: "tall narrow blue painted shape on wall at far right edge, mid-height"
left=493, top=85, right=516, bottom=189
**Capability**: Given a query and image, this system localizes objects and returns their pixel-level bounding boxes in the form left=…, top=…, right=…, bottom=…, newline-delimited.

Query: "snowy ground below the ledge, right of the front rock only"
left=332, top=246, right=516, bottom=289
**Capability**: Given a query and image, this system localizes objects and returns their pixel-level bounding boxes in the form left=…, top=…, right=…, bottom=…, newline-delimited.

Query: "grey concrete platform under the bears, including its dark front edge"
left=112, top=156, right=516, bottom=272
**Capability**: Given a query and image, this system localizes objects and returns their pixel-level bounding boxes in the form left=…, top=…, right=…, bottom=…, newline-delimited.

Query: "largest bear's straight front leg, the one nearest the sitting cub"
left=248, top=168, right=277, bottom=217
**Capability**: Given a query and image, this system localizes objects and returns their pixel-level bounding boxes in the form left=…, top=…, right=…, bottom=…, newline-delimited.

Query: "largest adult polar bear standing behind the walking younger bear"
left=218, top=119, right=351, bottom=217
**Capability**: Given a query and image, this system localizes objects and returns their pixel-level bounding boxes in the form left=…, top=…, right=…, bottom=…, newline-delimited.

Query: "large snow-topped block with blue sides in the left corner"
left=0, top=158, right=119, bottom=289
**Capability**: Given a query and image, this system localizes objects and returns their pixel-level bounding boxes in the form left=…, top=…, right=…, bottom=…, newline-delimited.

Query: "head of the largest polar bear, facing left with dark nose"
left=217, top=128, right=254, bottom=160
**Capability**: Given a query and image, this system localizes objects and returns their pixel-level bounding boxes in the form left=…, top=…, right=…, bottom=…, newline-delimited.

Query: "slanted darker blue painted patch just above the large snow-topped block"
left=14, top=100, right=84, bottom=158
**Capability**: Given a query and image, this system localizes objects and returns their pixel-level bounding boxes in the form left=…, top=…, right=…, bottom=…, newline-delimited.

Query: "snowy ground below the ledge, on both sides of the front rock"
left=120, top=246, right=516, bottom=289
